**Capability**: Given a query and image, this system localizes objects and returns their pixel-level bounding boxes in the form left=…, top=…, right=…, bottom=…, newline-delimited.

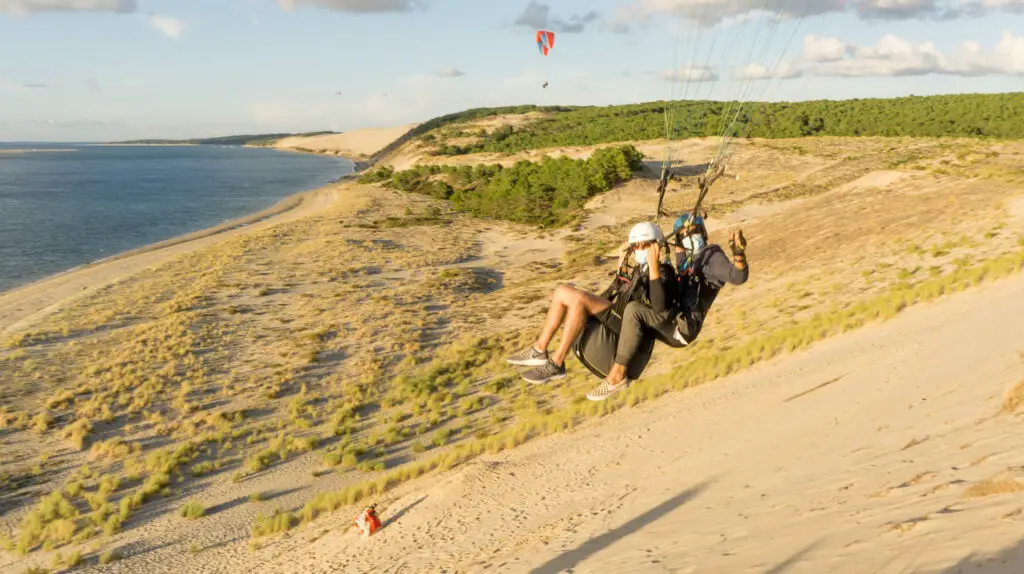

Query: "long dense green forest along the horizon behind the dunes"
left=423, top=92, right=1024, bottom=156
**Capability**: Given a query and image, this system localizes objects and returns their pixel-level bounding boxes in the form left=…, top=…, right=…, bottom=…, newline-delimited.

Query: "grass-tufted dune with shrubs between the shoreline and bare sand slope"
left=0, top=96, right=1024, bottom=567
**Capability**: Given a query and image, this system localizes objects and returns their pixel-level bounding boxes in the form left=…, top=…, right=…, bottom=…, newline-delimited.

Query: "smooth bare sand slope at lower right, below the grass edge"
left=257, top=268, right=1024, bottom=574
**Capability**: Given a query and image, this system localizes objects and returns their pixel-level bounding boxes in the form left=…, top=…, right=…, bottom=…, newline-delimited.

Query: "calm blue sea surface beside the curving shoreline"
left=0, top=142, right=352, bottom=293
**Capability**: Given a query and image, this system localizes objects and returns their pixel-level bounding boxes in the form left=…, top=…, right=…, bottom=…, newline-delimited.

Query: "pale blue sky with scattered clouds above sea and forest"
left=0, top=0, right=1024, bottom=141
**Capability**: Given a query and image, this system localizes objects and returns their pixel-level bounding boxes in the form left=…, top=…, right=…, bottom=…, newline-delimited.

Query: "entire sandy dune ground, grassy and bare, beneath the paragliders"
left=0, top=117, right=1024, bottom=574
